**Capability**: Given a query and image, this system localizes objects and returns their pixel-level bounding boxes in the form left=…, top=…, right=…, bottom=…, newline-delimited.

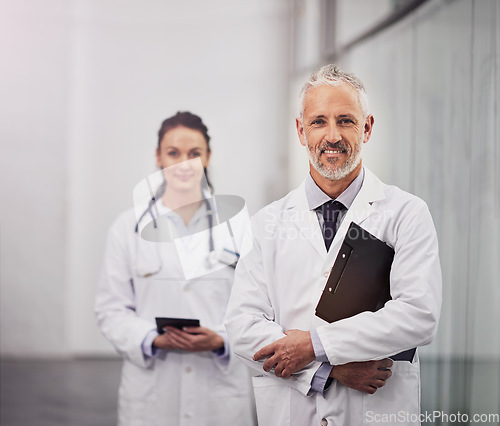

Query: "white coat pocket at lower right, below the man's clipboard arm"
left=363, top=361, right=420, bottom=426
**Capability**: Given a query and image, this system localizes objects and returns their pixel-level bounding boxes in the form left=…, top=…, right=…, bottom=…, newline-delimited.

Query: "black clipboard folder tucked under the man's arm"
left=316, top=222, right=416, bottom=362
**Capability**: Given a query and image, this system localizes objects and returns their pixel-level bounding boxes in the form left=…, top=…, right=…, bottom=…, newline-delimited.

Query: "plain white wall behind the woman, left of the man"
left=0, top=0, right=289, bottom=356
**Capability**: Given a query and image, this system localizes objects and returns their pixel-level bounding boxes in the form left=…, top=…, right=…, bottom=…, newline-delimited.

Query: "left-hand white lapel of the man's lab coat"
left=287, top=181, right=327, bottom=258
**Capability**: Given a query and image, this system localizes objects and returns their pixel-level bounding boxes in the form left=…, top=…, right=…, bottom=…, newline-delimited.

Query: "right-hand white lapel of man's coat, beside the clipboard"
left=325, top=167, right=385, bottom=265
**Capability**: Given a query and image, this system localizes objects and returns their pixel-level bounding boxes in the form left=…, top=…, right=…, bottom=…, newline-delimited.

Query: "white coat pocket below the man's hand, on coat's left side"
left=252, top=375, right=292, bottom=425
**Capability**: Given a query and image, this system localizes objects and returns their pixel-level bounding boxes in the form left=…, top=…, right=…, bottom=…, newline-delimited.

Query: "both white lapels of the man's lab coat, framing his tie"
left=285, top=167, right=385, bottom=263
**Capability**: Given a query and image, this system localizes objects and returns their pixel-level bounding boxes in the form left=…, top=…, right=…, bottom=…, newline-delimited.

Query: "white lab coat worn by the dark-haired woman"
left=95, top=205, right=253, bottom=426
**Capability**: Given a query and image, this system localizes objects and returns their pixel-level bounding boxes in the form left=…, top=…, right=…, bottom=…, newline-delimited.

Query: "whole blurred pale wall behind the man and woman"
left=0, top=0, right=500, bottom=422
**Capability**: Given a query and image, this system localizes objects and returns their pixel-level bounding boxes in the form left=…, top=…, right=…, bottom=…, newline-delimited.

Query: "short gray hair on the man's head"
left=299, top=64, right=368, bottom=120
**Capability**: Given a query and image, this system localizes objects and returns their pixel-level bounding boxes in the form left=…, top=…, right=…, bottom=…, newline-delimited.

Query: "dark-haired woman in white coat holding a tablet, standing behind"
left=95, top=112, right=253, bottom=426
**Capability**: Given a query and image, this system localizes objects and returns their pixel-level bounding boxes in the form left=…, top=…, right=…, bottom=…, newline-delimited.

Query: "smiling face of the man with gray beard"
left=296, top=83, right=373, bottom=181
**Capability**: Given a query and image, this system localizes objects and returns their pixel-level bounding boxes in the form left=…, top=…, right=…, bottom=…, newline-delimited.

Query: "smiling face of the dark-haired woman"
left=156, top=126, right=210, bottom=191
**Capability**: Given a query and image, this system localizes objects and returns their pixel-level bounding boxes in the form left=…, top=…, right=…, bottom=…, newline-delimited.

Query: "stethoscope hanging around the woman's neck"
left=135, top=183, right=240, bottom=277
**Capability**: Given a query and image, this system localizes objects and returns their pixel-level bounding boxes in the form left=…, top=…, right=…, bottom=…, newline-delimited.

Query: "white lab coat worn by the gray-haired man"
left=225, top=169, right=441, bottom=426
